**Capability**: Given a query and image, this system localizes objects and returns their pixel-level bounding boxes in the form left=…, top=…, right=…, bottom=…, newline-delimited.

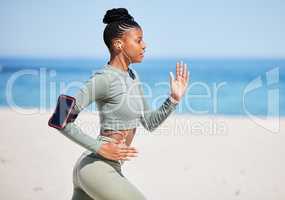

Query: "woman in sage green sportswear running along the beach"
left=51, top=8, right=189, bottom=200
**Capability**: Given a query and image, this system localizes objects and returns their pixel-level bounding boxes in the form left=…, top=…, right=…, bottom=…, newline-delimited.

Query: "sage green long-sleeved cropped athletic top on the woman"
left=60, top=64, right=177, bottom=153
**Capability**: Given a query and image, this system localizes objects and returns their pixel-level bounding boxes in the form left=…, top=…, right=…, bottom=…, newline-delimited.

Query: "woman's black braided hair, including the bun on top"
left=103, top=8, right=141, bottom=50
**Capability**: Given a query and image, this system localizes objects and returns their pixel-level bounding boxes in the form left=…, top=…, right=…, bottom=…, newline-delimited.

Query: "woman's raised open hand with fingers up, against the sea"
left=170, top=61, right=189, bottom=101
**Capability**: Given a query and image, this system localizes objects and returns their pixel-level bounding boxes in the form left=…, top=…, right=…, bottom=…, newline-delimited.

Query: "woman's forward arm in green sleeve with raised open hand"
left=138, top=63, right=189, bottom=131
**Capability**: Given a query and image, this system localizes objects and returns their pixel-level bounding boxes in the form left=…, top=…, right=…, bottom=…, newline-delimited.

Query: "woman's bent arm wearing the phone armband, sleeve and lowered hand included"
left=57, top=73, right=136, bottom=160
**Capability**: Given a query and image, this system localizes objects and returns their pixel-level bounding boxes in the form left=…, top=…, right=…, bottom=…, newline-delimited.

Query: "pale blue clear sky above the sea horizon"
left=0, top=0, right=285, bottom=58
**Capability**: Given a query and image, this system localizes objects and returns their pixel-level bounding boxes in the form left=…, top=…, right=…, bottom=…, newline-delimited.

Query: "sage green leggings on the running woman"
left=72, top=151, right=146, bottom=200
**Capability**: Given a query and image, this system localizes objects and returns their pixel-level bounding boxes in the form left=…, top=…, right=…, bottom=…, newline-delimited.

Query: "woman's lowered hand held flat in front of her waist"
left=98, top=140, right=138, bottom=160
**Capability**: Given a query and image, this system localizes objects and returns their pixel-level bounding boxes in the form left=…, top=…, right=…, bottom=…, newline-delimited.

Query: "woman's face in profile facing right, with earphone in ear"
left=121, top=28, right=146, bottom=63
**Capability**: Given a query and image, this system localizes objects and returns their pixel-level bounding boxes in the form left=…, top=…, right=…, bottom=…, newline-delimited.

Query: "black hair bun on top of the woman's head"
left=103, top=8, right=134, bottom=24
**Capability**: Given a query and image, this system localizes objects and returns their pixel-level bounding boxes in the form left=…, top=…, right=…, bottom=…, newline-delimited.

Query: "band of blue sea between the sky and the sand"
left=0, top=58, right=285, bottom=116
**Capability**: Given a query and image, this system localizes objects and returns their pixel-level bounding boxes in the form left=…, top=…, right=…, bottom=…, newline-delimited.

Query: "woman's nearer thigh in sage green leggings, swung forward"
left=78, top=160, right=145, bottom=200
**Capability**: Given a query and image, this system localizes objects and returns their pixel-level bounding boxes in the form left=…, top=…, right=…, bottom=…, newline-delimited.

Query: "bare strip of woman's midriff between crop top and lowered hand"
left=100, top=128, right=136, bottom=146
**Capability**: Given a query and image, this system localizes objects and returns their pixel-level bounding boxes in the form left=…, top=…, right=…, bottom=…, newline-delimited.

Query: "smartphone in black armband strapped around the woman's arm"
left=48, top=95, right=78, bottom=129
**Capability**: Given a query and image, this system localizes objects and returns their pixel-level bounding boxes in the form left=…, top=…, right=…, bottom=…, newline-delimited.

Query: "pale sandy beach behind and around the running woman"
left=0, top=108, right=285, bottom=200
